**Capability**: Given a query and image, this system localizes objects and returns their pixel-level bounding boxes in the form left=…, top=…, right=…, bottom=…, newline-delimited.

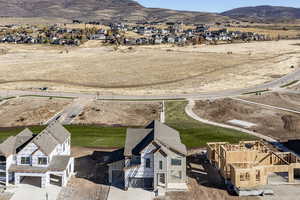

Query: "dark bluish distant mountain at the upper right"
left=221, top=6, right=300, bottom=22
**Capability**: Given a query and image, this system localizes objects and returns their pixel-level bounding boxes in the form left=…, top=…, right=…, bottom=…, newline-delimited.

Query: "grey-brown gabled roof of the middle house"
left=124, top=120, right=187, bottom=156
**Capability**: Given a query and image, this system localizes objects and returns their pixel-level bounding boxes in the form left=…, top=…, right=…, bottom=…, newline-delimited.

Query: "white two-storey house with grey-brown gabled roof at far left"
left=0, top=122, right=74, bottom=188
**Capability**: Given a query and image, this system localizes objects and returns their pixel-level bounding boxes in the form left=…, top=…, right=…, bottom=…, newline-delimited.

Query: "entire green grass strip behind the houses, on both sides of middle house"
left=0, top=101, right=255, bottom=148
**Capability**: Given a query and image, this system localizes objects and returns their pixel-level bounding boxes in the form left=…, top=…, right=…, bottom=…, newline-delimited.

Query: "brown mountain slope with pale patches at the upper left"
left=0, top=0, right=228, bottom=23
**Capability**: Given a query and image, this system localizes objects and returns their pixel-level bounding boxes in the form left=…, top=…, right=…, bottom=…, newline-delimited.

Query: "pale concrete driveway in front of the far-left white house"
left=7, top=184, right=61, bottom=200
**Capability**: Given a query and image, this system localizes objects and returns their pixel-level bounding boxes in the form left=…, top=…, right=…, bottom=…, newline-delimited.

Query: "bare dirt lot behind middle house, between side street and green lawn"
left=73, top=100, right=161, bottom=126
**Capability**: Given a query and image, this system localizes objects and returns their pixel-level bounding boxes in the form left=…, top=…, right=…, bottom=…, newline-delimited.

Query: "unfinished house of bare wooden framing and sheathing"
left=207, top=141, right=300, bottom=189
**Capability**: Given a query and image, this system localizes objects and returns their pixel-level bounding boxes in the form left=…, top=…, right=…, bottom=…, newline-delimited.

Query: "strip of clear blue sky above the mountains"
left=136, top=0, right=300, bottom=12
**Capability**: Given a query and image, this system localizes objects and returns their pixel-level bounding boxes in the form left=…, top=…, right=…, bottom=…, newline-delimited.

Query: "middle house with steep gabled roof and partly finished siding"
left=109, top=121, right=187, bottom=195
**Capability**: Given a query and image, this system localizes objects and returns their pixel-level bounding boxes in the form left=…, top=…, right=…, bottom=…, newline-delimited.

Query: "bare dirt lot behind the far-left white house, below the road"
left=0, top=97, right=72, bottom=127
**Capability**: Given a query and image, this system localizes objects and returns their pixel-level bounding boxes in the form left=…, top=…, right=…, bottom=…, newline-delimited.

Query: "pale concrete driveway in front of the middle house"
left=107, top=187, right=155, bottom=200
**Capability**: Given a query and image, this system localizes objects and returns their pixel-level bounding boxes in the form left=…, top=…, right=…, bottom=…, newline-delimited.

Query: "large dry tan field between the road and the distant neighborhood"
left=0, top=40, right=300, bottom=95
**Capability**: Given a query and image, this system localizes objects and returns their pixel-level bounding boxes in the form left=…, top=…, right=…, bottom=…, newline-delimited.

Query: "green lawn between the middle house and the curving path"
left=166, top=101, right=256, bottom=148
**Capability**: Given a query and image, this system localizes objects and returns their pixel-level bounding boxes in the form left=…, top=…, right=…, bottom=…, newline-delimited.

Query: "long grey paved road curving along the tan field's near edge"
left=0, top=69, right=300, bottom=100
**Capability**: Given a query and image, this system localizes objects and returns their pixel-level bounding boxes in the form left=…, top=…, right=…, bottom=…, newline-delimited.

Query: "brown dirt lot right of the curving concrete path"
left=194, top=94, right=300, bottom=140
